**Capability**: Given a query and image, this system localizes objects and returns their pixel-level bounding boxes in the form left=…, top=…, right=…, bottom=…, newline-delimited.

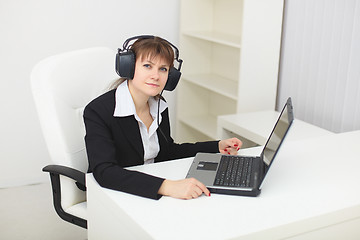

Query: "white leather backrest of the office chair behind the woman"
left=31, top=47, right=118, bottom=209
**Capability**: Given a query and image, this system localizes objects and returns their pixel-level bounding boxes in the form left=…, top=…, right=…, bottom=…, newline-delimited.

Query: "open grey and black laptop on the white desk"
left=186, top=98, right=294, bottom=197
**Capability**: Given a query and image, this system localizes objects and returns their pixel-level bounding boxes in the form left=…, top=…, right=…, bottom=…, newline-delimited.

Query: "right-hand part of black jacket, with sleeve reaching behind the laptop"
left=156, top=109, right=219, bottom=162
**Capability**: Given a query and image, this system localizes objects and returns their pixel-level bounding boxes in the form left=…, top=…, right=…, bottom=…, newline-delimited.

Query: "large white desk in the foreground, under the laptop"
left=87, top=130, right=360, bottom=240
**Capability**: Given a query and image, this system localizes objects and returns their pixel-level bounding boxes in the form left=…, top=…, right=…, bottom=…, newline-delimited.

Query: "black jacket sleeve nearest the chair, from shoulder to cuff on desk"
left=84, top=93, right=164, bottom=199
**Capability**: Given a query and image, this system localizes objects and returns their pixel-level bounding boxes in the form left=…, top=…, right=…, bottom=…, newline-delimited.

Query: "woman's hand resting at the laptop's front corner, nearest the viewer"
left=158, top=178, right=210, bottom=199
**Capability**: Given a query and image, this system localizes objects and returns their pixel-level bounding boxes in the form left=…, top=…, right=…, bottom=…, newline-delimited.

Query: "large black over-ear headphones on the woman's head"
left=115, top=35, right=182, bottom=91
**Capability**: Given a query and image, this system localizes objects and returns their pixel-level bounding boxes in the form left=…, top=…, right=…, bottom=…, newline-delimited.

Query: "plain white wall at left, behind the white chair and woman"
left=0, top=0, right=181, bottom=188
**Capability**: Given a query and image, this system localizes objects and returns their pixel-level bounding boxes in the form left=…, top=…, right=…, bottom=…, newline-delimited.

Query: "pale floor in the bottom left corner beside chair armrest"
left=0, top=183, right=87, bottom=240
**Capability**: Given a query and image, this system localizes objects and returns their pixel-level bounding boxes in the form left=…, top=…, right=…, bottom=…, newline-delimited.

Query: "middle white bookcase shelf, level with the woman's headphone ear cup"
left=183, top=74, right=238, bottom=101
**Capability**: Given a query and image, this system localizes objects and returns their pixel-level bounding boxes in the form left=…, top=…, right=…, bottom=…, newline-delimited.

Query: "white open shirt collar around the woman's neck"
left=114, top=80, right=168, bottom=117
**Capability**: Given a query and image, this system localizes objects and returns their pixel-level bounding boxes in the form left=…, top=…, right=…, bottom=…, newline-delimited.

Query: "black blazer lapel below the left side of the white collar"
left=116, top=116, right=144, bottom=159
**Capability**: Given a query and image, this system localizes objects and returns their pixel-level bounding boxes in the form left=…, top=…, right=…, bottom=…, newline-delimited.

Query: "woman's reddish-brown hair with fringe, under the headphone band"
left=109, top=37, right=174, bottom=89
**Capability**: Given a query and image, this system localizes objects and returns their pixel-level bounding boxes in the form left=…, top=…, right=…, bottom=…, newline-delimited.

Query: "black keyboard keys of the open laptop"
left=214, top=155, right=254, bottom=187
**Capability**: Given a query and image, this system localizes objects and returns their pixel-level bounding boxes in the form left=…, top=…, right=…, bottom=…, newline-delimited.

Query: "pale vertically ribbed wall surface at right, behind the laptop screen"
left=278, top=0, right=360, bottom=132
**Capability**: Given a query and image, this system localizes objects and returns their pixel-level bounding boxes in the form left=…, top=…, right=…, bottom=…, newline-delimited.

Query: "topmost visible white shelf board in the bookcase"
left=183, top=31, right=241, bottom=49
